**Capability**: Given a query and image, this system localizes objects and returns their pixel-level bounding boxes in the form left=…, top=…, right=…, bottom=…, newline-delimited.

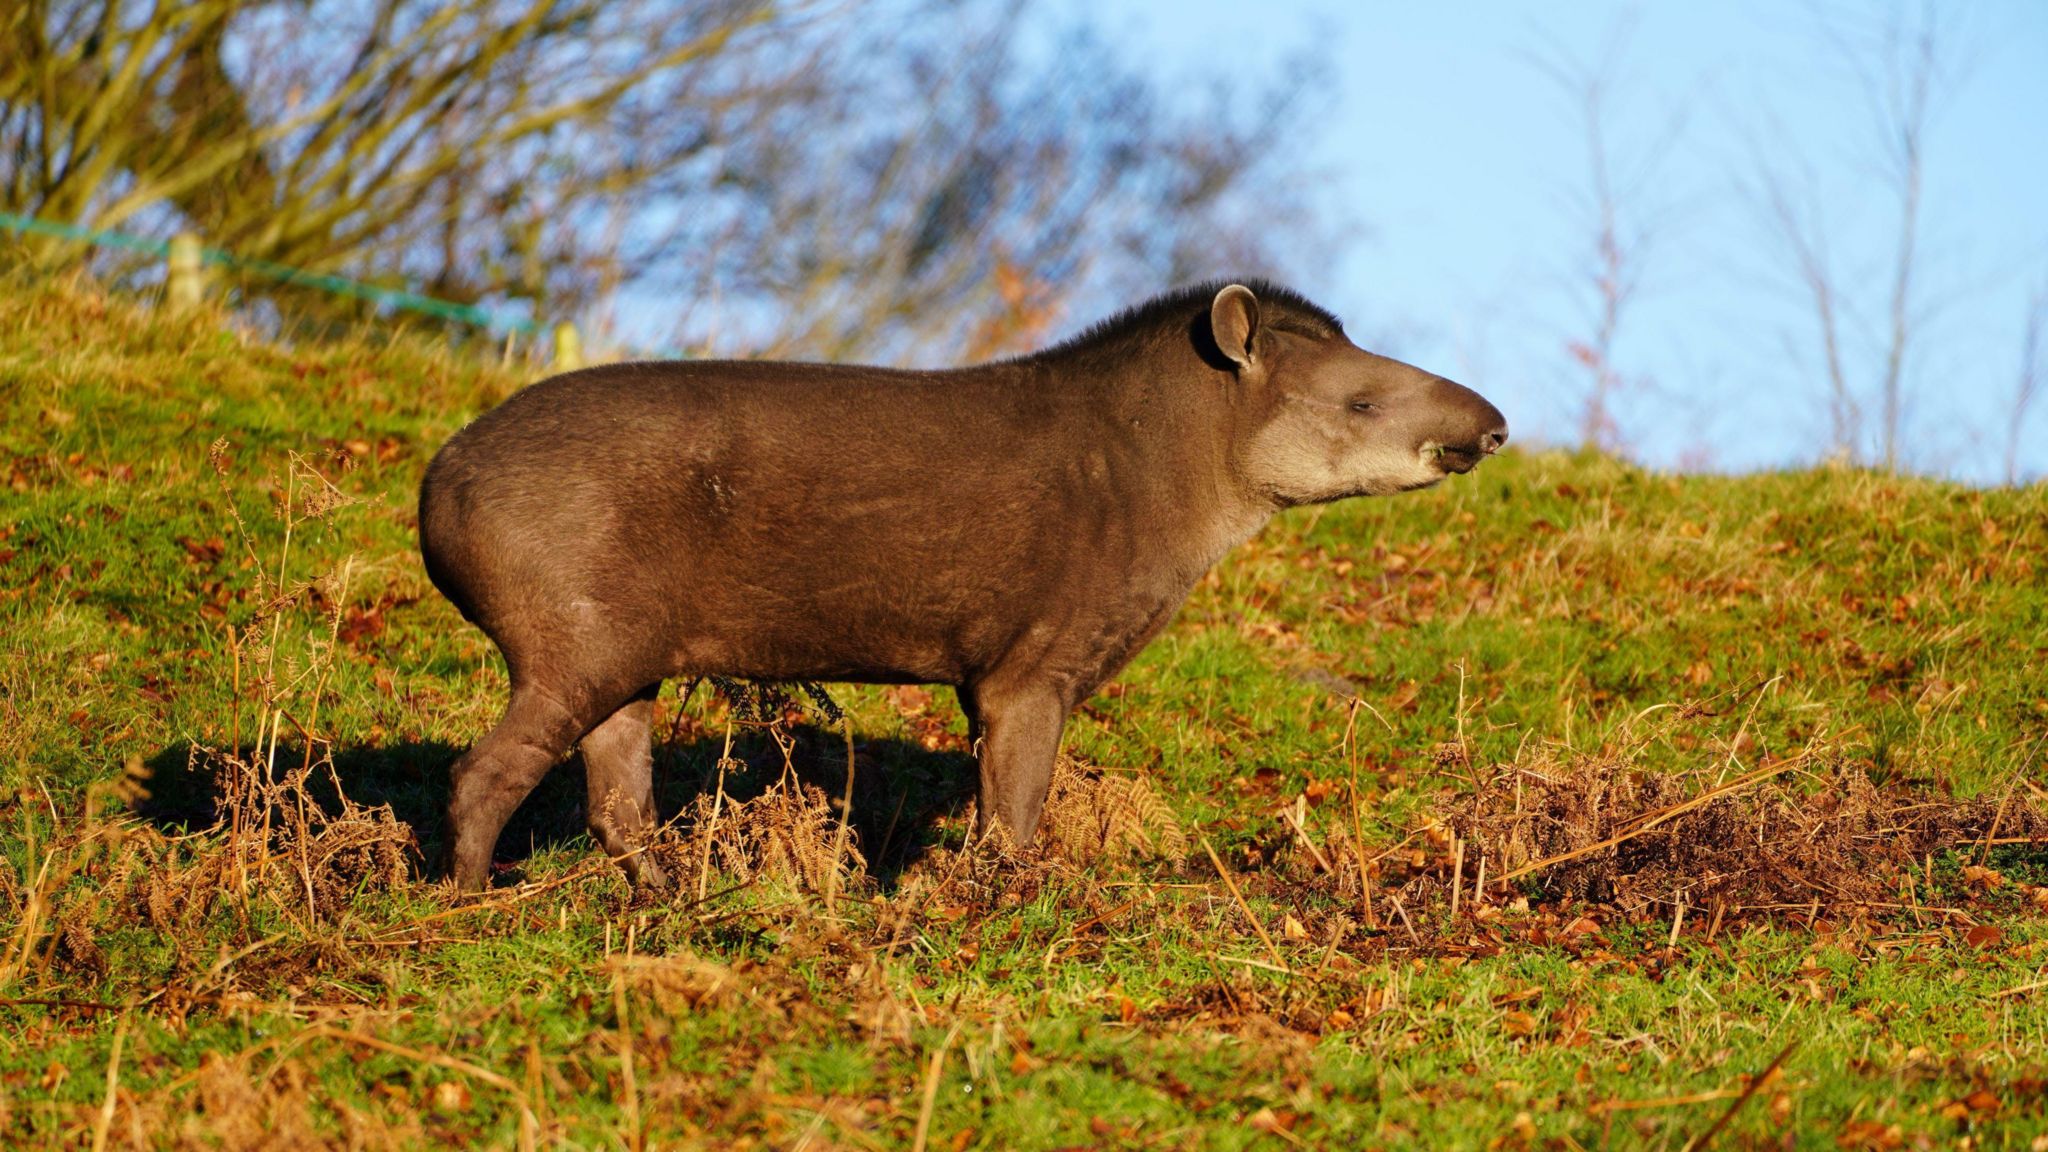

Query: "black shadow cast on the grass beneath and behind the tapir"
left=133, top=724, right=975, bottom=888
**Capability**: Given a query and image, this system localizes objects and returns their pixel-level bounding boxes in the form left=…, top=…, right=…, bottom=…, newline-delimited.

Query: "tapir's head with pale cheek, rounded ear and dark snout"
left=1208, top=285, right=1507, bottom=504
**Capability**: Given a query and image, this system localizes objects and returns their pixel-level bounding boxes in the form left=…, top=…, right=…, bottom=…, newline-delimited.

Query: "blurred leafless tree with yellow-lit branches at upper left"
left=0, top=0, right=811, bottom=317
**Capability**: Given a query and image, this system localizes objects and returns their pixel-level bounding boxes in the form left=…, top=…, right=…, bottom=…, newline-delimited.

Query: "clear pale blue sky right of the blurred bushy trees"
left=1067, top=0, right=2048, bottom=482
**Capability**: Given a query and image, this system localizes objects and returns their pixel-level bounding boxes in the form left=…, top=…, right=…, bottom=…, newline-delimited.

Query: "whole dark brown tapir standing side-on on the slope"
left=420, top=281, right=1507, bottom=890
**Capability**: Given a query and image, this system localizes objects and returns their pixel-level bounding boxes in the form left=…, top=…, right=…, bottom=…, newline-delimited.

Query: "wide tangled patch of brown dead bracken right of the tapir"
left=1243, top=685, right=2048, bottom=934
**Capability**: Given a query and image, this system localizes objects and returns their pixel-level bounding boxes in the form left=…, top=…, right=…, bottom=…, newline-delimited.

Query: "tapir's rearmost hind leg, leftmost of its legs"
left=449, top=681, right=616, bottom=892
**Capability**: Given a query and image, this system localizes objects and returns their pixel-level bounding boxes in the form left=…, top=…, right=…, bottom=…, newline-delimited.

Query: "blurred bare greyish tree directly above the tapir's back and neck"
left=659, top=10, right=1315, bottom=363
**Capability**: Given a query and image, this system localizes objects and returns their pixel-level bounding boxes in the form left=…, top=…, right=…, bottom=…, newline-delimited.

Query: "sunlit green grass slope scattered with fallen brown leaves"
left=0, top=287, right=2048, bottom=1148
